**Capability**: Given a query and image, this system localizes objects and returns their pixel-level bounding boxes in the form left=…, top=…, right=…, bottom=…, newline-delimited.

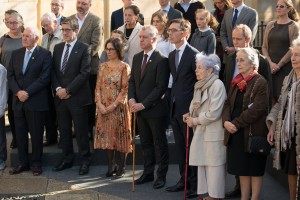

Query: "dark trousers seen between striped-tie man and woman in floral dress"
left=88, top=74, right=97, bottom=134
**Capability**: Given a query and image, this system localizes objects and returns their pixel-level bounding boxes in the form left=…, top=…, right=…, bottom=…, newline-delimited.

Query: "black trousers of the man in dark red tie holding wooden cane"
left=137, top=113, right=169, bottom=178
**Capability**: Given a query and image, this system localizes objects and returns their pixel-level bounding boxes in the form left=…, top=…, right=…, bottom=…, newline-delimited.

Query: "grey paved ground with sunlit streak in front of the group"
left=0, top=129, right=289, bottom=200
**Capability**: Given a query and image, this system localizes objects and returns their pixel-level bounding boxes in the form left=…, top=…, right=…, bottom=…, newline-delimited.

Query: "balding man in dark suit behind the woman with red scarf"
left=224, top=24, right=273, bottom=198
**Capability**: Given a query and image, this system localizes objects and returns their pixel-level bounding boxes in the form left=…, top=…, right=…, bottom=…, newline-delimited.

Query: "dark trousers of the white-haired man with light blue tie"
left=14, top=110, right=45, bottom=166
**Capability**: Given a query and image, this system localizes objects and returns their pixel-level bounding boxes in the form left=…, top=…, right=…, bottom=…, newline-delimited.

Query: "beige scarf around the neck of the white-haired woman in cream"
left=190, top=74, right=219, bottom=117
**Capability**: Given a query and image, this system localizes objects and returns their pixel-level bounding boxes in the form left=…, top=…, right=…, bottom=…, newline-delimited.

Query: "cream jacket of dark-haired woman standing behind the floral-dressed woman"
left=118, top=22, right=143, bottom=68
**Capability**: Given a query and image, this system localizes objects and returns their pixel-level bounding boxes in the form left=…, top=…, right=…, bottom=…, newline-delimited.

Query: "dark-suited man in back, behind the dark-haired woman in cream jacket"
left=110, top=0, right=144, bottom=31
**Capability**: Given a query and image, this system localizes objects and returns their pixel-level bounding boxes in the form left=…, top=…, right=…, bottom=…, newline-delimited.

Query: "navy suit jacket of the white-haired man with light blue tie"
left=7, top=46, right=52, bottom=111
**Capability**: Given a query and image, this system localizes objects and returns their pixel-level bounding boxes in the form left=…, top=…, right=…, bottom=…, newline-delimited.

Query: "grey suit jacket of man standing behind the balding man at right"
left=220, top=5, right=258, bottom=49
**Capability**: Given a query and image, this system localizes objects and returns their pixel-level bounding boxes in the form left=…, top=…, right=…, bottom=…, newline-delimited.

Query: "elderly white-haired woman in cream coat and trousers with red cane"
left=183, top=53, right=226, bottom=199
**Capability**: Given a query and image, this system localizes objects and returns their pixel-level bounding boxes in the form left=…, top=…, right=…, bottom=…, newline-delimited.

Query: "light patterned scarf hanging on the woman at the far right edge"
left=281, top=74, right=300, bottom=150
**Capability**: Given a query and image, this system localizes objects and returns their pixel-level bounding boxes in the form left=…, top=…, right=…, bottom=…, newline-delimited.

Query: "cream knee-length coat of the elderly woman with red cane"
left=189, top=79, right=226, bottom=166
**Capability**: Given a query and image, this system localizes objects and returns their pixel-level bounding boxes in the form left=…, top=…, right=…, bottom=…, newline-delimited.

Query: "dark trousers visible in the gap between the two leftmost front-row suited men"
left=45, top=87, right=57, bottom=143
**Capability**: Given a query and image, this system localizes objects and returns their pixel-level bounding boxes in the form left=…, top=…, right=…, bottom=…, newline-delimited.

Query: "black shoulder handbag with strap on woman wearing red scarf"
left=247, top=78, right=271, bottom=156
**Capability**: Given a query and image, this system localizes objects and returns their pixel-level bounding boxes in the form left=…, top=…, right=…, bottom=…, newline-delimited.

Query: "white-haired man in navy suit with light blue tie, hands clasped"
left=8, top=27, right=52, bottom=176
